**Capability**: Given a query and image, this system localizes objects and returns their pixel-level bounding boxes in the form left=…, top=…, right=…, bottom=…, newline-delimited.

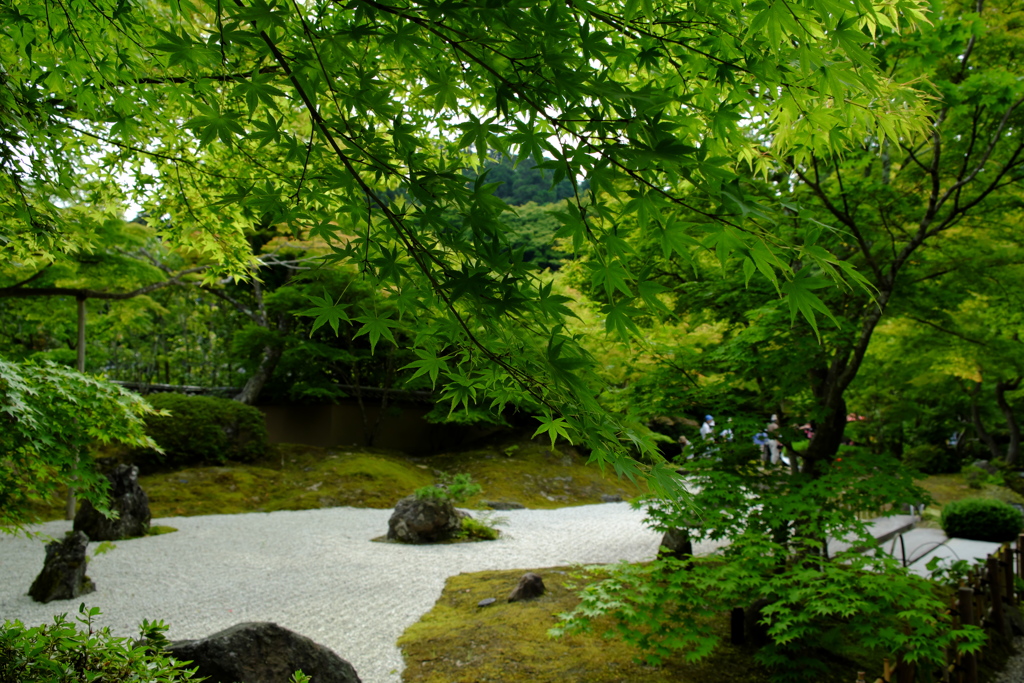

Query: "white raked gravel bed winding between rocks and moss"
left=0, top=503, right=710, bottom=683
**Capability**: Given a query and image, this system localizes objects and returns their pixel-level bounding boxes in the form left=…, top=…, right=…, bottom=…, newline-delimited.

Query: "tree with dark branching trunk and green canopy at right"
left=606, top=2, right=1024, bottom=469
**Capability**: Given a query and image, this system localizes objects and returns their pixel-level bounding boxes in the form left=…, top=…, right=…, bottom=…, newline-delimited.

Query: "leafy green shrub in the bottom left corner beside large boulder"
left=0, top=604, right=198, bottom=683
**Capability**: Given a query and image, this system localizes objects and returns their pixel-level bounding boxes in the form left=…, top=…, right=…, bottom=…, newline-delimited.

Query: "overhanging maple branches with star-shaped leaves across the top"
left=0, top=0, right=923, bottom=483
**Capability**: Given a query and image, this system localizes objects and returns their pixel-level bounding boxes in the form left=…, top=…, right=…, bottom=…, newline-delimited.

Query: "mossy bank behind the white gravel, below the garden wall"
left=29, top=438, right=642, bottom=520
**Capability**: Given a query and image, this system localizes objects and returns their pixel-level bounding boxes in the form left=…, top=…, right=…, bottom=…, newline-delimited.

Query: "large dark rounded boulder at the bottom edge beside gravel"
left=167, top=622, right=360, bottom=683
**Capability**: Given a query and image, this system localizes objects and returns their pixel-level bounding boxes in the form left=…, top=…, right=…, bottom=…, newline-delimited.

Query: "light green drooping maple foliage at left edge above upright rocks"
left=0, top=358, right=156, bottom=530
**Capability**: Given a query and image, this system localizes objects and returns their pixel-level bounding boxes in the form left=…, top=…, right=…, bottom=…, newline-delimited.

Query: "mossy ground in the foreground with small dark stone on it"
left=398, top=567, right=770, bottom=683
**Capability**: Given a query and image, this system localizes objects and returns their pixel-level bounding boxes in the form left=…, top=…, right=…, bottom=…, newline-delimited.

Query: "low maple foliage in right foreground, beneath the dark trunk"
left=560, top=446, right=984, bottom=681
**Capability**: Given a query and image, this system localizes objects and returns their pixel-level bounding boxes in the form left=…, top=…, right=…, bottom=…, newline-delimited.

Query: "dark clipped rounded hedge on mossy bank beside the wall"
left=135, top=393, right=267, bottom=469
